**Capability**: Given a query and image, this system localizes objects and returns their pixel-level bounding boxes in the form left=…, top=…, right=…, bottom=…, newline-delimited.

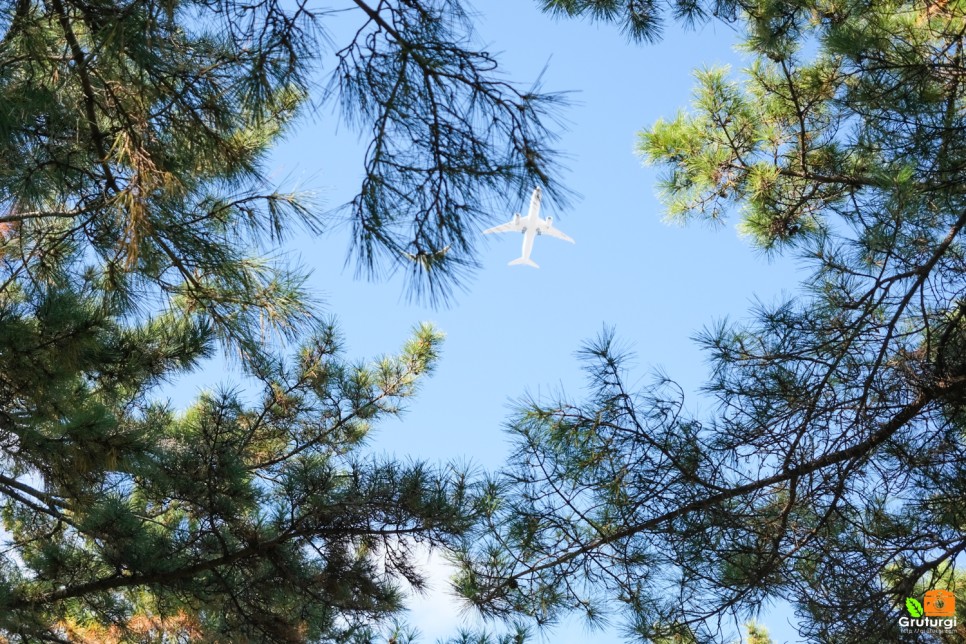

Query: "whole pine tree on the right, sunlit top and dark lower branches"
left=460, top=0, right=966, bottom=643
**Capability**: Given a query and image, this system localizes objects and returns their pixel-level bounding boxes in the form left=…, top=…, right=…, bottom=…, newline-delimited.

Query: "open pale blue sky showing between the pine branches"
left=173, top=0, right=799, bottom=644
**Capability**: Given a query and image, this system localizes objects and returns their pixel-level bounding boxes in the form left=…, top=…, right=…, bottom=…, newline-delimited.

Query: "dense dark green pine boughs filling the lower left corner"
left=0, top=293, right=474, bottom=640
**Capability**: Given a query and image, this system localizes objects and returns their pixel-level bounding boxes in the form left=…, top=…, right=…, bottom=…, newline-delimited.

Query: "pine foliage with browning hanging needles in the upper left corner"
left=0, top=0, right=318, bottom=356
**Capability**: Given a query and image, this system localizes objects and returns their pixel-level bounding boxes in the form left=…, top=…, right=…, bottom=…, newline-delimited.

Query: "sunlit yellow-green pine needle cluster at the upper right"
left=639, top=56, right=848, bottom=249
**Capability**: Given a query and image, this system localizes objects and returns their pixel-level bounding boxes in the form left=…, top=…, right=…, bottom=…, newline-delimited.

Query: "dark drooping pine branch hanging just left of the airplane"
left=331, top=0, right=567, bottom=298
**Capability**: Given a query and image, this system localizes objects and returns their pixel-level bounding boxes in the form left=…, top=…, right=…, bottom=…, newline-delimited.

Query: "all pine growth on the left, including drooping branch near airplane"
left=0, top=0, right=559, bottom=642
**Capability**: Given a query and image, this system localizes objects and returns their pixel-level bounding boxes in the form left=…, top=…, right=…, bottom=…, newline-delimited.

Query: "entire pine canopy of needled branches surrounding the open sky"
left=0, top=0, right=966, bottom=642
